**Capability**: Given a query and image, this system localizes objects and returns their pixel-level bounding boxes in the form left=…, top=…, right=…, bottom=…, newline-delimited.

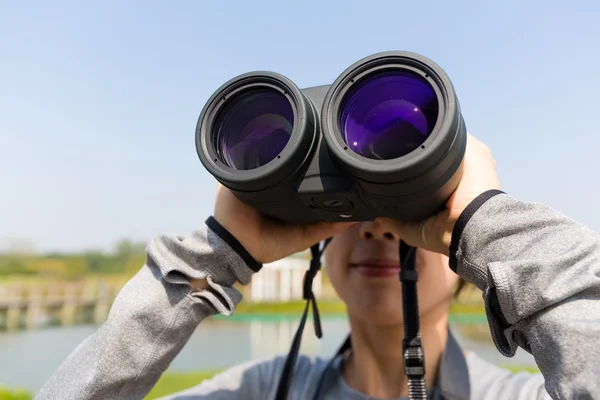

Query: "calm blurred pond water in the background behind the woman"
left=0, top=319, right=535, bottom=393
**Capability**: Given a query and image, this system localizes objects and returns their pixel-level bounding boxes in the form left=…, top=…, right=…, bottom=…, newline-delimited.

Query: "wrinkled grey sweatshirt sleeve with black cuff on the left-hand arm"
left=36, top=218, right=262, bottom=400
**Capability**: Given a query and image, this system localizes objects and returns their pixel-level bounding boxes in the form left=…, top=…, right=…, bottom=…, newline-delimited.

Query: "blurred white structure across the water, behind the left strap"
left=251, top=253, right=322, bottom=302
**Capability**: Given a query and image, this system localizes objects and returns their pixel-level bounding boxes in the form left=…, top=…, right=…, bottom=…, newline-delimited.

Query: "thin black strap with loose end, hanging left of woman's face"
left=275, top=238, right=331, bottom=400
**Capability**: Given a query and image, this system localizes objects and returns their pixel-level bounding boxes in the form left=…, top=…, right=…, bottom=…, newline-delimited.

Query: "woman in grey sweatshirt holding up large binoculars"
left=37, top=136, right=600, bottom=400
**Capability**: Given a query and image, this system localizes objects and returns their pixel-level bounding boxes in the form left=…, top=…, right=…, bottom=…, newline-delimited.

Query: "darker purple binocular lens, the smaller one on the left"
left=214, top=89, right=294, bottom=170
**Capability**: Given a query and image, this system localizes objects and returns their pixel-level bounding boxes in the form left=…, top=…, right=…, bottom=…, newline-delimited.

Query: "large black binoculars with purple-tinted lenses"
left=196, top=52, right=467, bottom=223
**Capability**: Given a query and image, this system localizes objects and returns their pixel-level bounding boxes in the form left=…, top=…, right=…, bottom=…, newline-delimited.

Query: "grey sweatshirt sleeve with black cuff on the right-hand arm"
left=450, top=191, right=600, bottom=399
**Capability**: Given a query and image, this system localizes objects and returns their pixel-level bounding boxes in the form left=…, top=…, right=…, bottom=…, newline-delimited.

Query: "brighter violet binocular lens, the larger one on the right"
left=339, top=71, right=438, bottom=160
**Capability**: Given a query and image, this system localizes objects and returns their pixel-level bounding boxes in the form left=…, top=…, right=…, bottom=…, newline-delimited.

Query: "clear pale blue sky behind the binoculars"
left=0, top=0, right=600, bottom=251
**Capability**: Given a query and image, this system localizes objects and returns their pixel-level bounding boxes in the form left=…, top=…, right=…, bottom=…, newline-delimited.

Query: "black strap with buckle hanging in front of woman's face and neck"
left=400, top=241, right=427, bottom=400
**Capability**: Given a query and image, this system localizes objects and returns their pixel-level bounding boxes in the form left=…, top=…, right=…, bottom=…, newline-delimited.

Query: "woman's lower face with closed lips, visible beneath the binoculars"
left=325, top=218, right=458, bottom=325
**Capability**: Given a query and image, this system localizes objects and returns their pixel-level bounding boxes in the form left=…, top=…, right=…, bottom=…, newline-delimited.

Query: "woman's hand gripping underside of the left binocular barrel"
left=214, top=184, right=354, bottom=263
